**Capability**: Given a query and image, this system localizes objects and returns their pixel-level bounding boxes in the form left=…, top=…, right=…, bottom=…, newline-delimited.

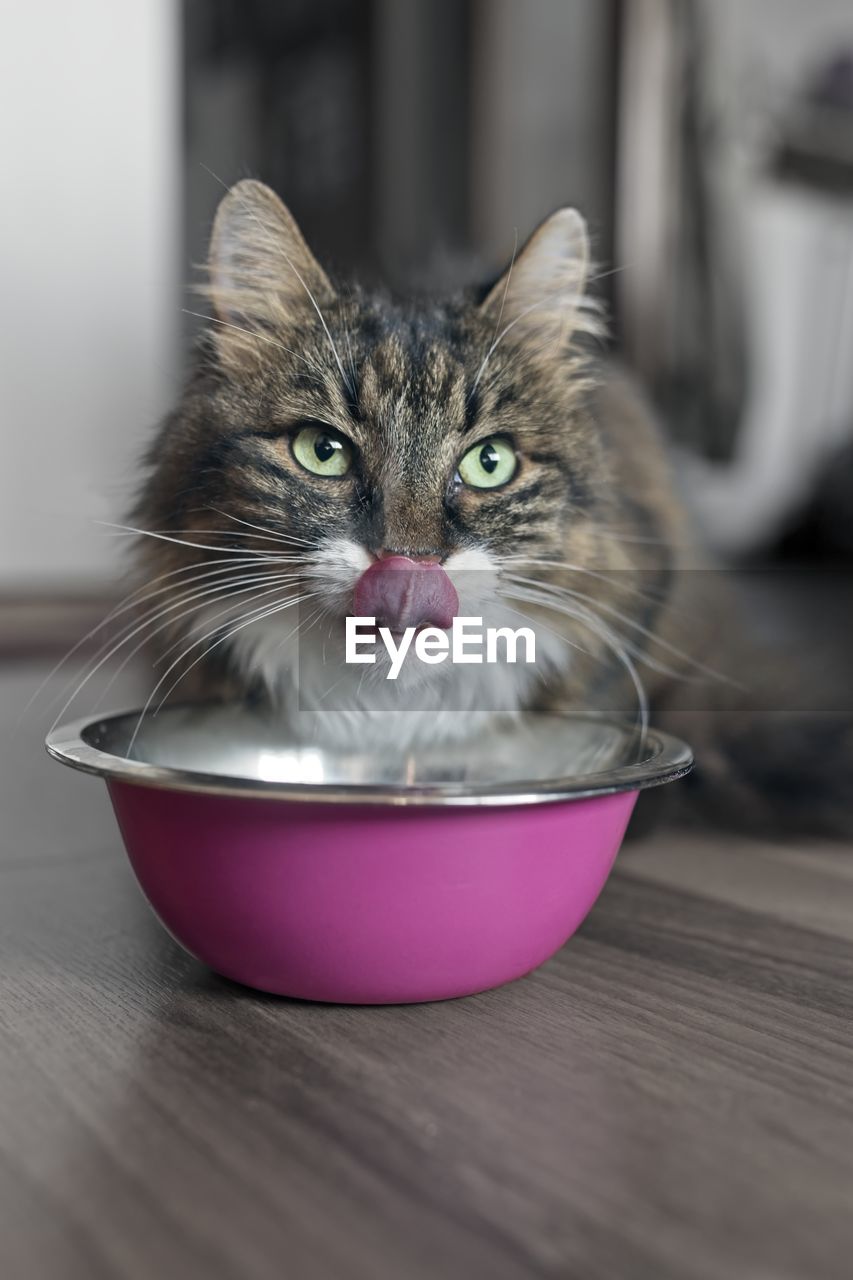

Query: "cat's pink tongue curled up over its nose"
left=355, top=556, right=459, bottom=631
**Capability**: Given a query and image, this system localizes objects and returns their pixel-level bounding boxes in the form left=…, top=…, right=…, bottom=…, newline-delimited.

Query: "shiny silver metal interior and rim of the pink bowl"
left=46, top=704, right=693, bottom=805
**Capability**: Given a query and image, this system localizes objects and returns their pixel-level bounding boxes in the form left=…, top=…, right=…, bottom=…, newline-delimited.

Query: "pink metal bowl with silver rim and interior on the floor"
left=46, top=704, right=692, bottom=1004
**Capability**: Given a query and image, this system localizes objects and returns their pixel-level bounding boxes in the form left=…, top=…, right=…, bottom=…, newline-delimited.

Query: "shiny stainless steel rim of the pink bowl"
left=45, top=712, right=693, bottom=808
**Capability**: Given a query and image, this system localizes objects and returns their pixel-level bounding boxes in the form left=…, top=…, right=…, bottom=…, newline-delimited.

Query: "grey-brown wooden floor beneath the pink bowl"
left=0, top=666, right=853, bottom=1280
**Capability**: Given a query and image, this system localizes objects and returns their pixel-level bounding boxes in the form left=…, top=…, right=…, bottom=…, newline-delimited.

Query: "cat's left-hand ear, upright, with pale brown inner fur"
left=204, top=179, right=334, bottom=367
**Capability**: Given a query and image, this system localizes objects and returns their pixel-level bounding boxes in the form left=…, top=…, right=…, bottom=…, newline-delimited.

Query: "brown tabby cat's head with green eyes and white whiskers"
left=137, top=182, right=605, bottom=742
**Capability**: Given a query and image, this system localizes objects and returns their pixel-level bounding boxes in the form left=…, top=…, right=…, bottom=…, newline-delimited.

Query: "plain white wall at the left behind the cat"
left=0, top=0, right=181, bottom=593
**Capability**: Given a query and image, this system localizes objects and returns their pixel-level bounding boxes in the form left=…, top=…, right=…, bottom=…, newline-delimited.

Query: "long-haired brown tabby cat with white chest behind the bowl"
left=133, top=180, right=847, bottom=839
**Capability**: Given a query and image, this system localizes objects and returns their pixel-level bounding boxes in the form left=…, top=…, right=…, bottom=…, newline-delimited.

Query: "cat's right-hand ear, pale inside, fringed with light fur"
left=480, top=209, right=601, bottom=343
